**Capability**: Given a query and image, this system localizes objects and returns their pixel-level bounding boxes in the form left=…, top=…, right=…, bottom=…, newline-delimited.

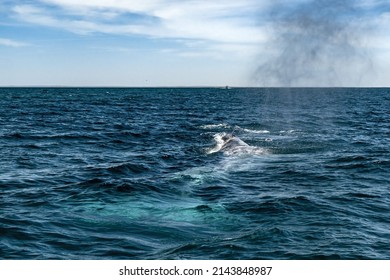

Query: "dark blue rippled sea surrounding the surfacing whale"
left=0, top=88, right=390, bottom=259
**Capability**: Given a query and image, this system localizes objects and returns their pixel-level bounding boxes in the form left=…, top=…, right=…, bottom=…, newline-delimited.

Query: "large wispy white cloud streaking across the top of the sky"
left=13, top=0, right=267, bottom=50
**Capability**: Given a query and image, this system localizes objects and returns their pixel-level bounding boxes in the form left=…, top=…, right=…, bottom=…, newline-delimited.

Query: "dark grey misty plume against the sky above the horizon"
left=253, top=0, right=373, bottom=87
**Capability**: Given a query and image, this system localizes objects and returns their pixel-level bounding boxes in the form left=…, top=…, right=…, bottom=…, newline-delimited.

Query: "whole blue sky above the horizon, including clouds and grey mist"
left=0, top=0, right=390, bottom=87
